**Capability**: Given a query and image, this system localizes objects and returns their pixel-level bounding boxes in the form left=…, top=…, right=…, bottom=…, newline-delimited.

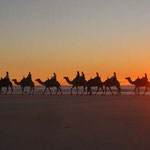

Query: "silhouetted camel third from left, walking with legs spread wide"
left=36, top=79, right=62, bottom=95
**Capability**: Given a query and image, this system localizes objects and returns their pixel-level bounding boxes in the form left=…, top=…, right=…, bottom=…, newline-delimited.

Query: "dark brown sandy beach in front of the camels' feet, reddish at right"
left=0, top=95, right=150, bottom=150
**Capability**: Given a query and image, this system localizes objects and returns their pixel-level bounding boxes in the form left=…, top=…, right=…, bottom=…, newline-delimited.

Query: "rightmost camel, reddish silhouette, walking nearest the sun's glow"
left=125, top=77, right=150, bottom=95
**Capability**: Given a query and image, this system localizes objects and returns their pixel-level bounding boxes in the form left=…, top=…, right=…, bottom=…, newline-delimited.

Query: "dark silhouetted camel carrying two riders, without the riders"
left=64, top=77, right=87, bottom=95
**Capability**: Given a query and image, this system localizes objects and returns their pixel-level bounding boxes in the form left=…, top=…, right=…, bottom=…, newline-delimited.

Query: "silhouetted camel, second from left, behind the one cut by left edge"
left=12, top=78, right=34, bottom=94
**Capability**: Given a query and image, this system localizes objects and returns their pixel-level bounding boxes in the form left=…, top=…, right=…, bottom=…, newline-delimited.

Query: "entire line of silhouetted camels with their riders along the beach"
left=0, top=71, right=150, bottom=95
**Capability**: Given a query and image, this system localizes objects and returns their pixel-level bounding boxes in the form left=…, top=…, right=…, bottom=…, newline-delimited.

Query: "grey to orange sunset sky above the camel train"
left=0, top=0, right=150, bottom=85
